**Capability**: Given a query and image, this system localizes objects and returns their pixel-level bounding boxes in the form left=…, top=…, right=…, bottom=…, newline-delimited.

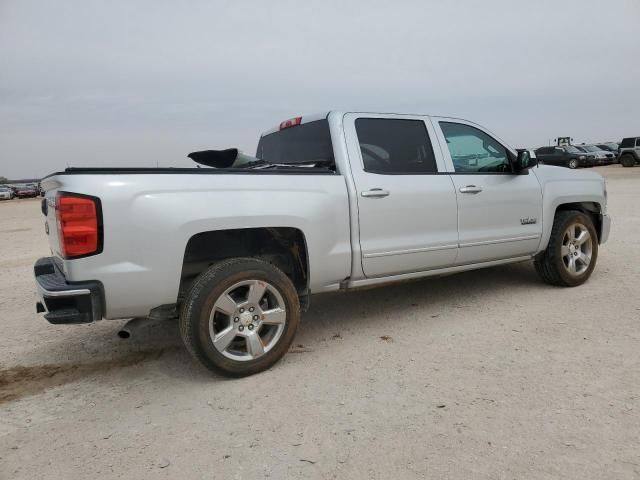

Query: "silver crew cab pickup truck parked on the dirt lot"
left=35, top=111, right=610, bottom=376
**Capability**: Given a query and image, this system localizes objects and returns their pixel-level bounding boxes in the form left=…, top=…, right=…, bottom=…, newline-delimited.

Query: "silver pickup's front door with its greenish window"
left=434, top=119, right=542, bottom=265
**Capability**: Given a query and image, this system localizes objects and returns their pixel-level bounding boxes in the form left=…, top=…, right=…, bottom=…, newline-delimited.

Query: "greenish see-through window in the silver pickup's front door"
left=440, top=122, right=512, bottom=173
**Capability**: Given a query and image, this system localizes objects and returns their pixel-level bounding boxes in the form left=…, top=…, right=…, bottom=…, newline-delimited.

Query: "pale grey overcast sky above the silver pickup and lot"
left=0, top=0, right=640, bottom=178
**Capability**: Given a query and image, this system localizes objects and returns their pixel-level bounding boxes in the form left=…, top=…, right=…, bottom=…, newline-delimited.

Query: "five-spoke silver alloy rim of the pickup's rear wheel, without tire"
left=209, top=280, right=287, bottom=362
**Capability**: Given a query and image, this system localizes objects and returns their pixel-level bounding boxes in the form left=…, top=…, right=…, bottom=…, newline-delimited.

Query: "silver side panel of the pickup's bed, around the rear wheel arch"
left=43, top=169, right=351, bottom=319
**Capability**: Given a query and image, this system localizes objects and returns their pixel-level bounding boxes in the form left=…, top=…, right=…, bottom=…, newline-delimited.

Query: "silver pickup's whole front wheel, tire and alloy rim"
left=534, top=211, right=598, bottom=287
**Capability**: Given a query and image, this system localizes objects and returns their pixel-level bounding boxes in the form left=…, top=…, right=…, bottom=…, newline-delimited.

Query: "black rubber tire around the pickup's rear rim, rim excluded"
left=180, top=258, right=300, bottom=377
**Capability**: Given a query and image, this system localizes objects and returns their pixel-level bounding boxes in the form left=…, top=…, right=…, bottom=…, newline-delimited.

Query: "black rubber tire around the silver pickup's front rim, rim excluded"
left=534, top=210, right=598, bottom=287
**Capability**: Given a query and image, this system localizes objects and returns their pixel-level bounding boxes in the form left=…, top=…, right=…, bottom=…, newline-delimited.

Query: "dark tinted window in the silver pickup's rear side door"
left=355, top=118, right=438, bottom=175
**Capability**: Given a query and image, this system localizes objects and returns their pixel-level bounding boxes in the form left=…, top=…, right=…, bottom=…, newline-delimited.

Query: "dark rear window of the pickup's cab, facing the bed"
left=256, top=119, right=333, bottom=164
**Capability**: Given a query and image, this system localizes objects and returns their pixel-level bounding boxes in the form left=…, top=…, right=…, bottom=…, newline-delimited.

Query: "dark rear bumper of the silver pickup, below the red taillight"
left=33, top=257, right=104, bottom=324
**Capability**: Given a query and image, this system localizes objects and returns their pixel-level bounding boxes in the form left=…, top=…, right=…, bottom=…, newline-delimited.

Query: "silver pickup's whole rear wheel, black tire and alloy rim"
left=180, top=258, right=300, bottom=377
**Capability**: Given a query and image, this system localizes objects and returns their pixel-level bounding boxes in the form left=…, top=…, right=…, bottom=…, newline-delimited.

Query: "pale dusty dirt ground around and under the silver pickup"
left=0, top=165, right=640, bottom=480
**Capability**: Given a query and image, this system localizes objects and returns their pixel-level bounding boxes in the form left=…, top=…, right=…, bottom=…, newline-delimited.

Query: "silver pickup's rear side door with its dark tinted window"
left=344, top=114, right=458, bottom=277
